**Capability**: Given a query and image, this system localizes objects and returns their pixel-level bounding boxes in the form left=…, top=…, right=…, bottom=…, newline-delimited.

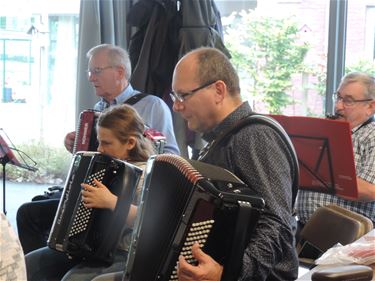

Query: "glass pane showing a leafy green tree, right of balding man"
left=223, top=0, right=329, bottom=116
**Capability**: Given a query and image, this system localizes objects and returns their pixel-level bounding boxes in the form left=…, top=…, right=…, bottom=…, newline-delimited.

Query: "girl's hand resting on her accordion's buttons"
left=81, top=179, right=117, bottom=210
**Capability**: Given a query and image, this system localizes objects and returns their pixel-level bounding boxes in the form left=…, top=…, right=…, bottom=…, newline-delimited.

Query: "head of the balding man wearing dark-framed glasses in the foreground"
left=172, top=48, right=242, bottom=132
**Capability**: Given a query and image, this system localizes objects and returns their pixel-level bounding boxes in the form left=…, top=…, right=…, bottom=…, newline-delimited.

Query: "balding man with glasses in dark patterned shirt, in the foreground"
left=171, top=48, right=298, bottom=281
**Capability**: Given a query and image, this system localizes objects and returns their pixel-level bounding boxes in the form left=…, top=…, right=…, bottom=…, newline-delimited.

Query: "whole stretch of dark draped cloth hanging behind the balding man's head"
left=128, top=0, right=229, bottom=157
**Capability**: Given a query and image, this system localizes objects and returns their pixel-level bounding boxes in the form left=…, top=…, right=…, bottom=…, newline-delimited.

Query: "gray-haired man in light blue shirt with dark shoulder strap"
left=64, top=44, right=180, bottom=154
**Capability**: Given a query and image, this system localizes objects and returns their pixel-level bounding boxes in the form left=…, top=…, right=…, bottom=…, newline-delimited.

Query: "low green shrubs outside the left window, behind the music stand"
left=6, top=141, right=72, bottom=184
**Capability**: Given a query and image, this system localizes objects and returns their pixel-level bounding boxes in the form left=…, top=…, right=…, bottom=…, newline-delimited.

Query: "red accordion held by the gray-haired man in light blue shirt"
left=73, top=109, right=166, bottom=154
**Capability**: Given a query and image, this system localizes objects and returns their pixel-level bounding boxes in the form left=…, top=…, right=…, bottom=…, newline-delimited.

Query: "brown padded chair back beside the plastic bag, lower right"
left=297, top=204, right=373, bottom=268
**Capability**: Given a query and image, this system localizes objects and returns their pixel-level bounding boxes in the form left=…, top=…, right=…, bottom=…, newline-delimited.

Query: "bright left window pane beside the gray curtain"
left=0, top=0, right=80, bottom=186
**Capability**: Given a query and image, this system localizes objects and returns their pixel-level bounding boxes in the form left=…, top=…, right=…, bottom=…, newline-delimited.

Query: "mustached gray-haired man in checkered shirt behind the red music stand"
left=297, top=72, right=375, bottom=227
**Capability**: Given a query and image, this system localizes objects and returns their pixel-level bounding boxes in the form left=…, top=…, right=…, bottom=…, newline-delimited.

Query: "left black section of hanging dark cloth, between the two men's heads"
left=128, top=0, right=181, bottom=98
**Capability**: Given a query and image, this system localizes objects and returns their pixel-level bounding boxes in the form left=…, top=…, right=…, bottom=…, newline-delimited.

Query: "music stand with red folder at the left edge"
left=0, top=128, right=37, bottom=215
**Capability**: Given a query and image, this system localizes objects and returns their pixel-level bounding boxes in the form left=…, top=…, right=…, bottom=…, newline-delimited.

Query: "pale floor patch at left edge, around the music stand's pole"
left=0, top=178, right=50, bottom=232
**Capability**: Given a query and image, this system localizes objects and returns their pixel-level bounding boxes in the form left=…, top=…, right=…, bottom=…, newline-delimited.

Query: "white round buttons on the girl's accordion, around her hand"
left=69, top=169, right=105, bottom=237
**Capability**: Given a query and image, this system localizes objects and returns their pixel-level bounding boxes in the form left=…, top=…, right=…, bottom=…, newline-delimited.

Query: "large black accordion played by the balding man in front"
left=123, top=154, right=264, bottom=281
